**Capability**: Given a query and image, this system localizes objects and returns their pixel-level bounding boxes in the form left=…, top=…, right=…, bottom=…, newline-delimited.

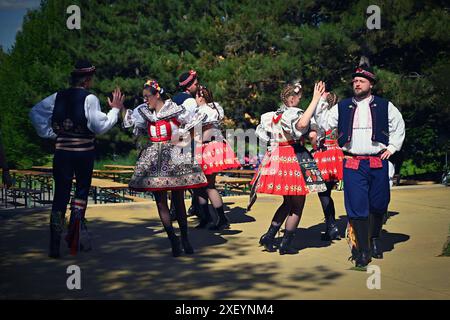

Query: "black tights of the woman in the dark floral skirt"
left=153, top=190, right=187, bottom=237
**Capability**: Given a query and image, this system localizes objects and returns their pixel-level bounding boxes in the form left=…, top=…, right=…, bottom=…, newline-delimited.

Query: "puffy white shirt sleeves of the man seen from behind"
left=29, top=93, right=120, bottom=139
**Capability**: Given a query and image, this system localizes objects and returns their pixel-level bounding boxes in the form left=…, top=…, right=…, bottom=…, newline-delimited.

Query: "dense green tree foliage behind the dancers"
left=0, top=0, right=450, bottom=170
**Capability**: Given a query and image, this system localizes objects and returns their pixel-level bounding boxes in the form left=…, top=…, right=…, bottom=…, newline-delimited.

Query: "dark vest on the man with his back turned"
left=52, top=88, right=94, bottom=138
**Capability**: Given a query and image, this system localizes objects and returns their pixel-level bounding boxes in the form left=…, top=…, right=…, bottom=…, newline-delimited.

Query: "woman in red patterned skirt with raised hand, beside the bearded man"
left=252, top=82, right=326, bottom=254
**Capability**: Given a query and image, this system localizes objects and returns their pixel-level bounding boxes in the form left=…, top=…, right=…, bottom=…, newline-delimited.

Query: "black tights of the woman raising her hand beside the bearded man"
left=272, top=196, right=306, bottom=231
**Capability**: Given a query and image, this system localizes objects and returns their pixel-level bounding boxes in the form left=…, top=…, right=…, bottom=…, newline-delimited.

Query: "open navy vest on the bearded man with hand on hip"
left=338, top=96, right=389, bottom=148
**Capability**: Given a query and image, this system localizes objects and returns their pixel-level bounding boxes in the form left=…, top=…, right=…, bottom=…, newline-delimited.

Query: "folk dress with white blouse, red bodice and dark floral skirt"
left=124, top=100, right=207, bottom=191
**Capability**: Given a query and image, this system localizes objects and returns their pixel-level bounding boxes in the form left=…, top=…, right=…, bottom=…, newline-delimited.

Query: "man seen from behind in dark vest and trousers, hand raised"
left=30, top=60, right=124, bottom=258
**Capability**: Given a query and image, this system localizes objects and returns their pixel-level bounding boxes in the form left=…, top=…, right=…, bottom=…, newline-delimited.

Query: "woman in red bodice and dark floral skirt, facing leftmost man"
left=124, top=80, right=207, bottom=257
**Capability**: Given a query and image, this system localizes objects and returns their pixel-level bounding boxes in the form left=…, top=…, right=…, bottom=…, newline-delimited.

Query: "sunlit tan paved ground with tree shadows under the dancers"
left=0, top=186, right=450, bottom=299
